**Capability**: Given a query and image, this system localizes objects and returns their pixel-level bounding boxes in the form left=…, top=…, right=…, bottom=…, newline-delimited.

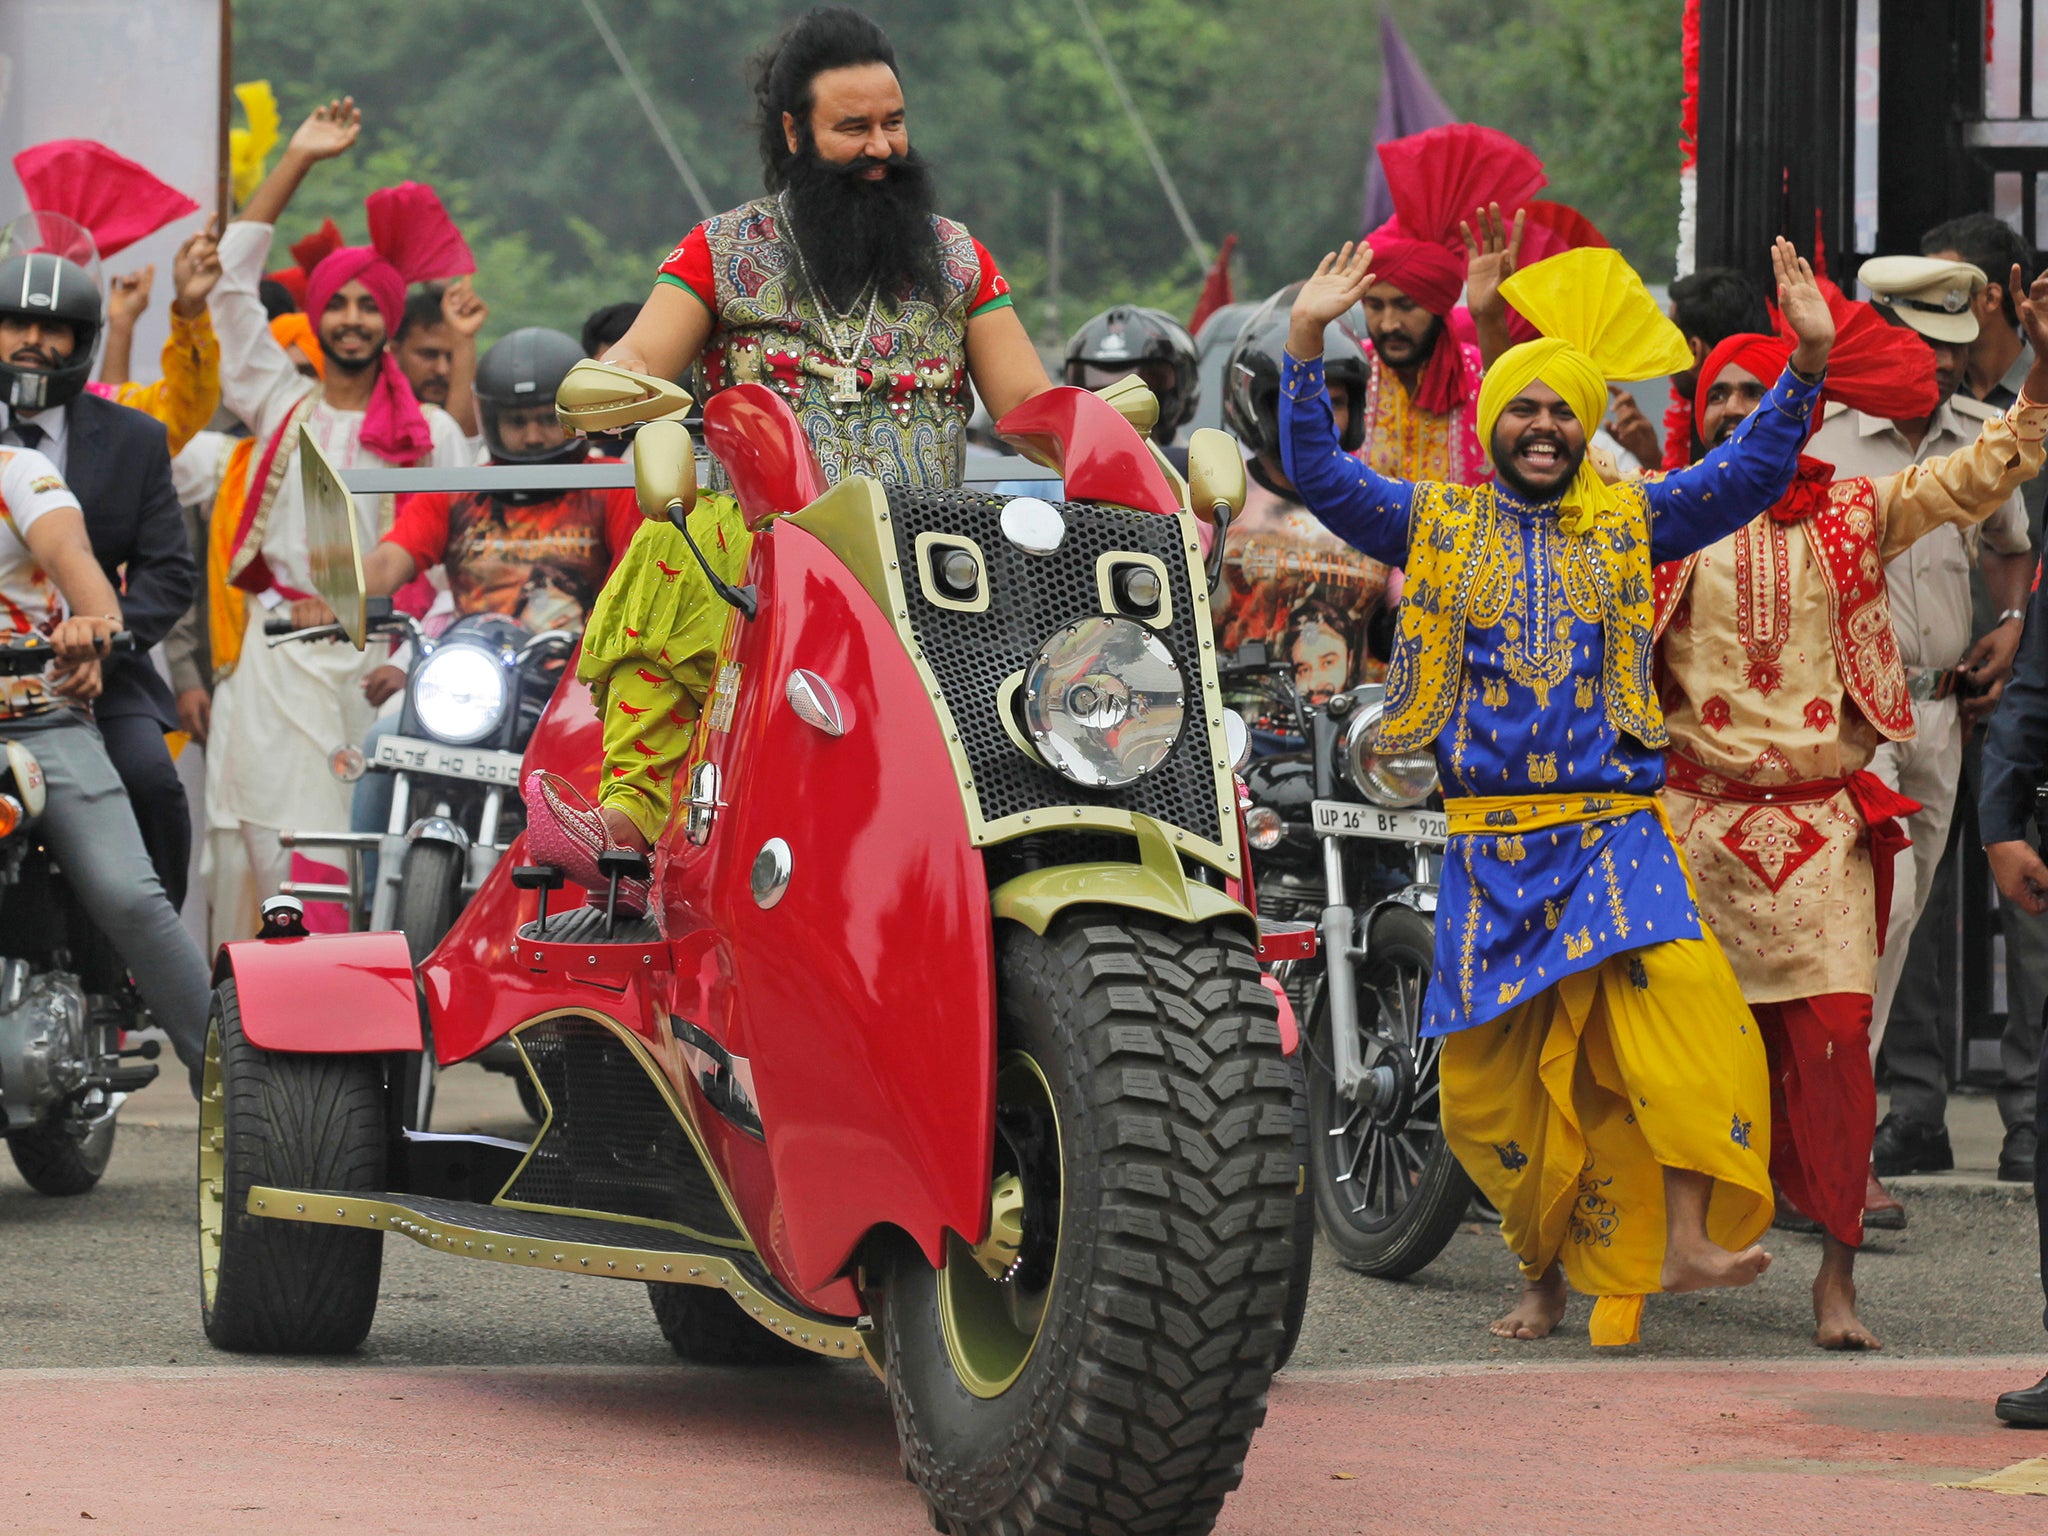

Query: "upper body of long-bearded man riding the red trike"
left=604, top=6, right=1053, bottom=485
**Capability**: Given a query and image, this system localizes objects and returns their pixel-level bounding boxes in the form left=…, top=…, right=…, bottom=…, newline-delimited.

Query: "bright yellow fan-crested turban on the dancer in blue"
left=1479, top=246, right=1692, bottom=532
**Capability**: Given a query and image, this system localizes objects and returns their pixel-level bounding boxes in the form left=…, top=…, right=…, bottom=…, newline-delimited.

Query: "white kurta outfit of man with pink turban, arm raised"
left=207, top=221, right=471, bottom=938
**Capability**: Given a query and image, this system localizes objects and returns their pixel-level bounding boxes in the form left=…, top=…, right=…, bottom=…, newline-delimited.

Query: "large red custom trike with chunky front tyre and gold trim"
left=199, top=365, right=1300, bottom=1532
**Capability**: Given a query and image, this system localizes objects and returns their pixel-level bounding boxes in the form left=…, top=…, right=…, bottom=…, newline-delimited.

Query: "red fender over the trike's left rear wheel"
left=213, top=934, right=424, bottom=1055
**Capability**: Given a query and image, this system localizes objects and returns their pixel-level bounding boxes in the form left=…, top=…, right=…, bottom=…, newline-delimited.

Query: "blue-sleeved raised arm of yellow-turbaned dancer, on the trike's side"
left=1280, top=244, right=1415, bottom=565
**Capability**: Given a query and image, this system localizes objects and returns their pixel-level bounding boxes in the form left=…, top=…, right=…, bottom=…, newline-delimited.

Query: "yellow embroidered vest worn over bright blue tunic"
left=1378, top=483, right=1671, bottom=752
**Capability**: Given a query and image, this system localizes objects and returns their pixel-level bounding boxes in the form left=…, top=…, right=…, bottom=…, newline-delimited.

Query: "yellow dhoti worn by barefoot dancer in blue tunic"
left=1442, top=932, right=1772, bottom=1343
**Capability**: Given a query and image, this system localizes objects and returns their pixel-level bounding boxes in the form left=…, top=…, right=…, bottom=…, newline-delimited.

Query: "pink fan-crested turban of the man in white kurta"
left=293, top=182, right=477, bottom=463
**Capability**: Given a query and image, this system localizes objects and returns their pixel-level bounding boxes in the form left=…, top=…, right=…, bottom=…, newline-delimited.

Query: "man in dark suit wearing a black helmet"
left=0, top=254, right=197, bottom=907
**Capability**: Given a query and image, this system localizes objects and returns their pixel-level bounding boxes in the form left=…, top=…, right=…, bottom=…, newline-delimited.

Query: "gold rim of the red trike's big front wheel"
left=938, top=1051, right=1067, bottom=1399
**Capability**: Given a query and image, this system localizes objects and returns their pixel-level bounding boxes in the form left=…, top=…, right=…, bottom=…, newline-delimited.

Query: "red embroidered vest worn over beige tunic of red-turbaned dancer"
left=1657, top=479, right=1913, bottom=741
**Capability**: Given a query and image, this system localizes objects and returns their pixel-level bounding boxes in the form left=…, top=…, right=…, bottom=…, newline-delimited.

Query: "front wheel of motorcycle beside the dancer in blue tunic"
left=1309, top=907, right=1473, bottom=1280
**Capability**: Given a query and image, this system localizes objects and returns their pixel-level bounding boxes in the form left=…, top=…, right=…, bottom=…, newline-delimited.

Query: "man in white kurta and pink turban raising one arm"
left=207, top=100, right=475, bottom=942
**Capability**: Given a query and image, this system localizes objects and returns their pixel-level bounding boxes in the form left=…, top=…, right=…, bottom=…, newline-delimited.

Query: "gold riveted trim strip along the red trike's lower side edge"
left=248, top=1184, right=866, bottom=1360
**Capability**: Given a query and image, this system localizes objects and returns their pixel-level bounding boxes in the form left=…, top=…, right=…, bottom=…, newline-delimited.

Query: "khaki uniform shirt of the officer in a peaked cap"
left=1806, top=395, right=2028, bottom=678
